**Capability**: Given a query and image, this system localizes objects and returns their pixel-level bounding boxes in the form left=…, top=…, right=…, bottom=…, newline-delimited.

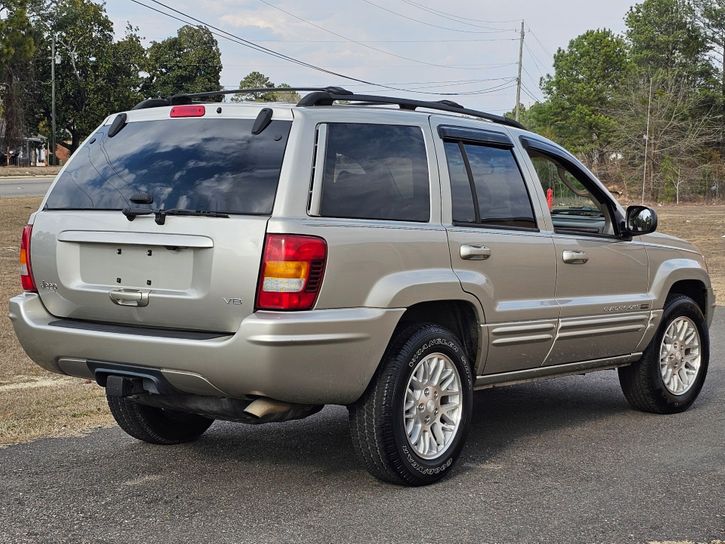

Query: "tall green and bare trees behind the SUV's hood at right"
left=521, top=0, right=725, bottom=200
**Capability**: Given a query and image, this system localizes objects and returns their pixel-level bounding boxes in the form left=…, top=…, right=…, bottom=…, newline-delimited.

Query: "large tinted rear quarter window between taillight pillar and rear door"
left=320, top=123, right=430, bottom=222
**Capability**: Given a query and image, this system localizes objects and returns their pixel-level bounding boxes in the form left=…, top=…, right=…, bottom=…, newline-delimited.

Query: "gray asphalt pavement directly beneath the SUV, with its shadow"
left=0, top=309, right=725, bottom=544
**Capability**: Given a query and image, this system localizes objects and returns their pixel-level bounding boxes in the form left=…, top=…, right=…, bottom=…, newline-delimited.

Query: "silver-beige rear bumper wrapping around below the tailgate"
left=10, top=293, right=405, bottom=404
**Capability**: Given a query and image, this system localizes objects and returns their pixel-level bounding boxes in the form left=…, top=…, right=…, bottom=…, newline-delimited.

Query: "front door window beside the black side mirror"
left=529, top=150, right=613, bottom=234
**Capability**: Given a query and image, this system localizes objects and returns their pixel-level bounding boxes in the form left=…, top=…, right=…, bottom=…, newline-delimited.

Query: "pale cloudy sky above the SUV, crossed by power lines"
left=106, top=0, right=634, bottom=113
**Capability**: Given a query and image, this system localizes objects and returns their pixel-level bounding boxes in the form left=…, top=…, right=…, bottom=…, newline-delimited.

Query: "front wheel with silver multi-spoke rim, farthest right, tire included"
left=619, top=295, right=710, bottom=414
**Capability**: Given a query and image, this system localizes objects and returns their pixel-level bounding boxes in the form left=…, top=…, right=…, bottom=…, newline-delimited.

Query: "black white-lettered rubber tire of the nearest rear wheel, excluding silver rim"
left=348, top=324, right=473, bottom=486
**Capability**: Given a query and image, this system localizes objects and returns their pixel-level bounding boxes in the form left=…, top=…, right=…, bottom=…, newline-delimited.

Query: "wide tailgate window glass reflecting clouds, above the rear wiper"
left=46, top=119, right=292, bottom=215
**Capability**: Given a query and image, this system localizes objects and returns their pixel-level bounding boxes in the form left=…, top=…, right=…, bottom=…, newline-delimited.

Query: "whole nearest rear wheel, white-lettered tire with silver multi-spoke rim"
left=349, top=324, right=473, bottom=486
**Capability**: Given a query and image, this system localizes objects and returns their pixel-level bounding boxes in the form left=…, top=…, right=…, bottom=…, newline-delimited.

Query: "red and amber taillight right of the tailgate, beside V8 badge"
left=257, top=234, right=327, bottom=310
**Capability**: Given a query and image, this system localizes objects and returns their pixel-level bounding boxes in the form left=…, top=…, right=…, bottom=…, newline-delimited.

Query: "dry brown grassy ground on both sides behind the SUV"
left=0, top=197, right=725, bottom=447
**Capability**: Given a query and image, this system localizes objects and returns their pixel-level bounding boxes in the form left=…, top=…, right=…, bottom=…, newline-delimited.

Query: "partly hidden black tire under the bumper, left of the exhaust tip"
left=106, top=396, right=214, bottom=445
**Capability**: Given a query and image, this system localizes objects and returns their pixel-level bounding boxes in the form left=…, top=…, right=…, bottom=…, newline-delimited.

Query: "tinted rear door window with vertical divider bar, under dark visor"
left=438, top=142, right=536, bottom=229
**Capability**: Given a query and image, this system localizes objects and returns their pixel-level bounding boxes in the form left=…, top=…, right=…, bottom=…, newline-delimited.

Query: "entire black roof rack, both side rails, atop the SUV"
left=133, top=87, right=524, bottom=128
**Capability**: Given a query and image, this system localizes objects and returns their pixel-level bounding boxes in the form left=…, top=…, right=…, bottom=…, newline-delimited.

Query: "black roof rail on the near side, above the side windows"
left=297, top=88, right=524, bottom=129
